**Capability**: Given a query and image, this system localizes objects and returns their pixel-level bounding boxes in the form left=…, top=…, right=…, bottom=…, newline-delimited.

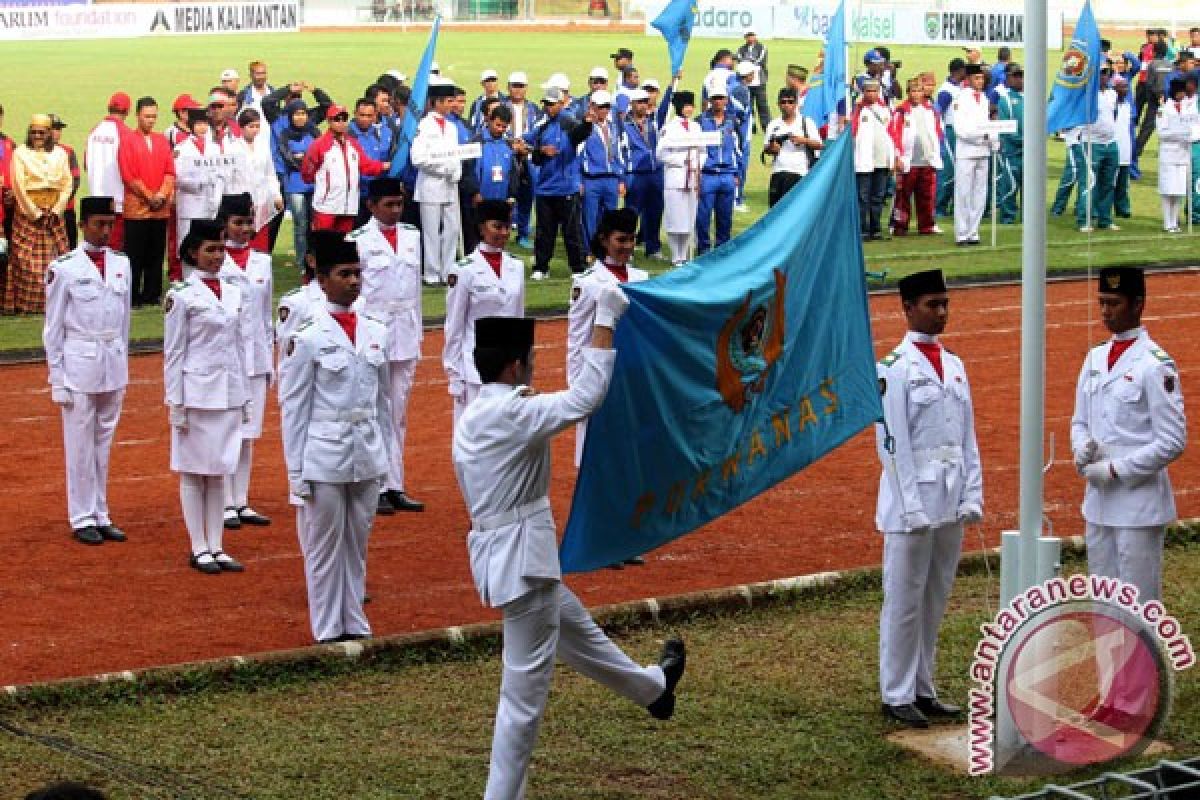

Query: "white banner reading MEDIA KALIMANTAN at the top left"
left=0, top=0, right=300, bottom=41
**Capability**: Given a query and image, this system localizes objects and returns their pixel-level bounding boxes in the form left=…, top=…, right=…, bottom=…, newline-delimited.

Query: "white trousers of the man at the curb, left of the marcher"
left=296, top=480, right=379, bottom=642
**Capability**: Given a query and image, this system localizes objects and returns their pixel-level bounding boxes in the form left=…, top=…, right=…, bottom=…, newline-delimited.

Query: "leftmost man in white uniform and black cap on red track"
left=42, top=197, right=130, bottom=545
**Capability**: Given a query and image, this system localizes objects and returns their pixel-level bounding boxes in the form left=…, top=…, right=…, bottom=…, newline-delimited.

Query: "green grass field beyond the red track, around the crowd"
left=0, top=29, right=1196, bottom=350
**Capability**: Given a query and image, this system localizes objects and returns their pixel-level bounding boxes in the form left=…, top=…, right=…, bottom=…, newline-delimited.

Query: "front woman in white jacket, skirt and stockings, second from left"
left=163, top=219, right=251, bottom=575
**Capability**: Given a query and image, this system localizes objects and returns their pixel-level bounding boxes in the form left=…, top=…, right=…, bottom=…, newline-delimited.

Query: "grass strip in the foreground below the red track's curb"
left=0, top=543, right=1200, bottom=800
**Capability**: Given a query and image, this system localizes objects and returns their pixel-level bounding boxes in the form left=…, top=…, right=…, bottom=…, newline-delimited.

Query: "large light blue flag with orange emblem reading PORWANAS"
left=560, top=133, right=882, bottom=572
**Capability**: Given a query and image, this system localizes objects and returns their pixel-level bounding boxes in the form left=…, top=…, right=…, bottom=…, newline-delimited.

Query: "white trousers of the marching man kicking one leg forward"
left=484, top=582, right=666, bottom=800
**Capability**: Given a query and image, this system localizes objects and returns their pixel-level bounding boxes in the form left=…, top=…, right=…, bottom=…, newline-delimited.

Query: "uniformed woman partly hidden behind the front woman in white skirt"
left=218, top=193, right=275, bottom=530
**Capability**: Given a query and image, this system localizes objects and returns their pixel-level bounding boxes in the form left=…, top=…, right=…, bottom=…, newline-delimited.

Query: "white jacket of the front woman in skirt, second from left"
left=162, top=270, right=250, bottom=410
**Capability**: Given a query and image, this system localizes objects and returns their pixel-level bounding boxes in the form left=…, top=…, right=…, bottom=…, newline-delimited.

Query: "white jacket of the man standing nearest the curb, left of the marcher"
left=280, top=306, right=396, bottom=483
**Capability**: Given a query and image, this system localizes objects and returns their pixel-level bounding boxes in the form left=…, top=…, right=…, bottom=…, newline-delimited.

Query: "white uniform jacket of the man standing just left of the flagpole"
left=875, top=332, right=983, bottom=534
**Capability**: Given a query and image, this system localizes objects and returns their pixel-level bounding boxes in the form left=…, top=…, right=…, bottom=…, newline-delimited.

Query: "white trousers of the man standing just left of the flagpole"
left=880, top=525, right=962, bottom=705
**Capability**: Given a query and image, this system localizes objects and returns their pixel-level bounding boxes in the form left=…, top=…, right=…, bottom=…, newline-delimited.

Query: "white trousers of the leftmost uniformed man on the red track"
left=62, top=389, right=125, bottom=529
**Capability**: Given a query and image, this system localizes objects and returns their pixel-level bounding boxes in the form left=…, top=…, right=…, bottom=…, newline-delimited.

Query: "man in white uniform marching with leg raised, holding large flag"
left=454, top=311, right=686, bottom=800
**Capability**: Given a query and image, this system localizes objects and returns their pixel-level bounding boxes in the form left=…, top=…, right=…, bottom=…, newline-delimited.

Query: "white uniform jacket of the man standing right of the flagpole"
left=1070, top=329, right=1188, bottom=528
